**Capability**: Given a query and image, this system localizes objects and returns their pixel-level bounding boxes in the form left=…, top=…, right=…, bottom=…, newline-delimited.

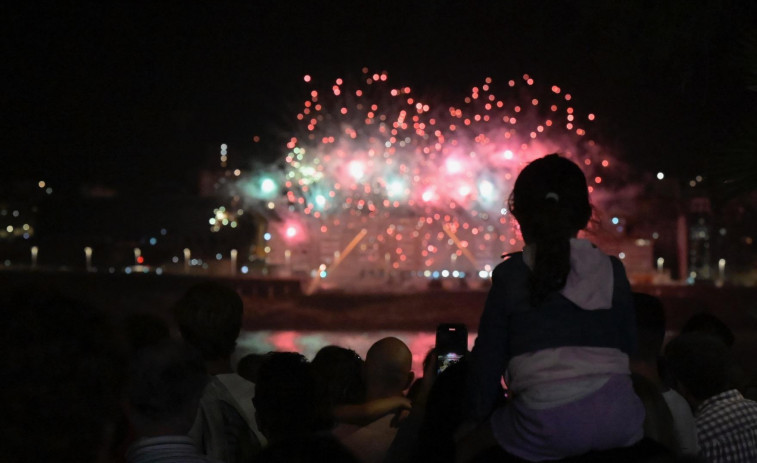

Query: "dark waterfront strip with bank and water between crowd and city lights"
left=5, top=271, right=757, bottom=371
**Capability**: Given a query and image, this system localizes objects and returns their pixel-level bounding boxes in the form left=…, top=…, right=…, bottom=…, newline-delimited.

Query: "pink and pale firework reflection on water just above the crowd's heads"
left=233, top=331, right=476, bottom=377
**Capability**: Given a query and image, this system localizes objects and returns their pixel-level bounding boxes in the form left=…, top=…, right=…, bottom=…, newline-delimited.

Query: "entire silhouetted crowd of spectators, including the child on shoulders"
left=0, top=155, right=757, bottom=463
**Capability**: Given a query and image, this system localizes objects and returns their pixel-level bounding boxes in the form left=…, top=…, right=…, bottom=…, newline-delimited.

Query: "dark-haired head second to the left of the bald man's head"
left=252, top=352, right=323, bottom=443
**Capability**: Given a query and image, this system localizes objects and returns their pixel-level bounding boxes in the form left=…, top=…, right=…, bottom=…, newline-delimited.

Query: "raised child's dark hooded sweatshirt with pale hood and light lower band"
left=467, top=239, right=636, bottom=421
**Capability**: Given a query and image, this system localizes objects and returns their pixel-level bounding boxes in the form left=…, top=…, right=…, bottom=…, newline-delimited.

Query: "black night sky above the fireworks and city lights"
left=0, top=0, right=757, bottom=198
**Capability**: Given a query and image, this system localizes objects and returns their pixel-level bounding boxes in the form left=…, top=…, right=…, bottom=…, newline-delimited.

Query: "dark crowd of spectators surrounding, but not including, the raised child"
left=5, top=283, right=757, bottom=463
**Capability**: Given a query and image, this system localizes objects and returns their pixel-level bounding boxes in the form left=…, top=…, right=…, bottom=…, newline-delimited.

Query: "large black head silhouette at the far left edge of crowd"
left=0, top=290, right=126, bottom=462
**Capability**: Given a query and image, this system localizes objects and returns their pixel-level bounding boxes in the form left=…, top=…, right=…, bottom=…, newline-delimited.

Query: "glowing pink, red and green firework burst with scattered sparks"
left=221, top=69, right=609, bottom=286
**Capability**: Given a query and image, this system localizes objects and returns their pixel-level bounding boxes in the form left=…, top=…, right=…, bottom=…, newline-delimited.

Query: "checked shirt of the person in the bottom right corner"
left=696, top=389, right=757, bottom=463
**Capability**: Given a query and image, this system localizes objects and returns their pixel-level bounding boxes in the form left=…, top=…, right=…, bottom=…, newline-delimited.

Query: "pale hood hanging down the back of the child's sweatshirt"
left=523, top=238, right=614, bottom=310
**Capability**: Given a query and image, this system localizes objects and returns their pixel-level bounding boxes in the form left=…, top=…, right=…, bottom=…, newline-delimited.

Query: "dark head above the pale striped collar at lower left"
left=127, top=340, right=209, bottom=437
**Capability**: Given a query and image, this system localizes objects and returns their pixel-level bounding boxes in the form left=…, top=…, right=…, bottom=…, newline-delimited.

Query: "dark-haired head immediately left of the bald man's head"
left=311, top=346, right=365, bottom=407
